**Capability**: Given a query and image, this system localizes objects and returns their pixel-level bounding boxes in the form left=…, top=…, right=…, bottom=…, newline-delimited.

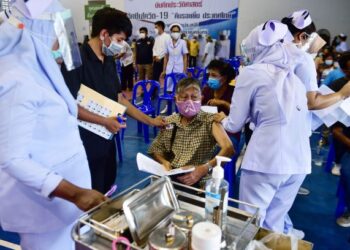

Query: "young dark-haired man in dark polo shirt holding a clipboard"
left=62, top=7, right=164, bottom=193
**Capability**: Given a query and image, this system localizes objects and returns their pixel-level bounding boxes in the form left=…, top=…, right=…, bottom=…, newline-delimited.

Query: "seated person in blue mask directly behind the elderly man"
left=202, top=60, right=240, bottom=152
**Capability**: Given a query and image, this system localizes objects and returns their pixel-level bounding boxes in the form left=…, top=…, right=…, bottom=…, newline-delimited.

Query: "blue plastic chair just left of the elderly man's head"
left=157, top=73, right=187, bottom=115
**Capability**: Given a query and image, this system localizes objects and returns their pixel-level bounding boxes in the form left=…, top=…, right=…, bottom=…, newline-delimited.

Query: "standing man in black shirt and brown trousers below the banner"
left=135, top=27, right=154, bottom=80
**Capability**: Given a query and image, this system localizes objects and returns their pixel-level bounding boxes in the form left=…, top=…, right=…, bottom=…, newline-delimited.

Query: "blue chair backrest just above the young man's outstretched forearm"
left=131, top=80, right=160, bottom=106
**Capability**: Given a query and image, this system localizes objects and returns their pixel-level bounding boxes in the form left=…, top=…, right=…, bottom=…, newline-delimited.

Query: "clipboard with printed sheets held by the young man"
left=77, top=84, right=126, bottom=140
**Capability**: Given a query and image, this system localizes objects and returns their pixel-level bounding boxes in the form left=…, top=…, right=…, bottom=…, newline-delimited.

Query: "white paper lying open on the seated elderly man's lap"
left=136, top=153, right=194, bottom=176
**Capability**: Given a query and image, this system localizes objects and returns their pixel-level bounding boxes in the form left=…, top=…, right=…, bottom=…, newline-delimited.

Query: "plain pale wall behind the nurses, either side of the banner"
left=61, top=0, right=350, bottom=52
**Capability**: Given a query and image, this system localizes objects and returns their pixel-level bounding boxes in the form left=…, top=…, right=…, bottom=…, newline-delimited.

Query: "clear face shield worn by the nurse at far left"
left=53, top=10, right=82, bottom=71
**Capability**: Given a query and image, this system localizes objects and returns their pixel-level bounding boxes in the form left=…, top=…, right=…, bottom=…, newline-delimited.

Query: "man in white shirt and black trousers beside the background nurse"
left=153, top=21, right=171, bottom=81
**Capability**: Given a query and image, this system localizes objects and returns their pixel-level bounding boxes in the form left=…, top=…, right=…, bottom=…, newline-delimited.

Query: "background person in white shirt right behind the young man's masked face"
left=116, top=41, right=134, bottom=91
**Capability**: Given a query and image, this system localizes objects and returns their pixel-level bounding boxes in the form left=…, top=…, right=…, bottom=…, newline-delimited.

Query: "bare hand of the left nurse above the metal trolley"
left=73, top=188, right=107, bottom=211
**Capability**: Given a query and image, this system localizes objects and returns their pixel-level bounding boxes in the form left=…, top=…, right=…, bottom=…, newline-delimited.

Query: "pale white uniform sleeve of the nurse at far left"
left=0, top=79, right=63, bottom=197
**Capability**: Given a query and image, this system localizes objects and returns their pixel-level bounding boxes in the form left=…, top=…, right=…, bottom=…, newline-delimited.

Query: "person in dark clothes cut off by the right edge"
left=329, top=52, right=350, bottom=227
